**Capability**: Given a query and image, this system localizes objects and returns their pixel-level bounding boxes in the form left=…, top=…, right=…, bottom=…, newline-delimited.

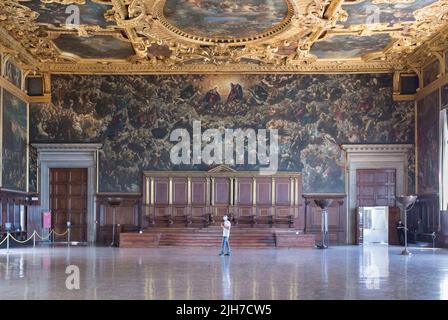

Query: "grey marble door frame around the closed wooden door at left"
left=32, top=143, right=102, bottom=243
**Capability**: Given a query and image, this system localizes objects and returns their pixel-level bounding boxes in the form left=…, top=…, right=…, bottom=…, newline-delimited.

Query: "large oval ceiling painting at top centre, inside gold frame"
left=163, top=0, right=288, bottom=39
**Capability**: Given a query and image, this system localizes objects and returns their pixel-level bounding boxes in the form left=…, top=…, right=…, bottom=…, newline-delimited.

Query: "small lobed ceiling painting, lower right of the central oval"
left=310, top=34, right=391, bottom=59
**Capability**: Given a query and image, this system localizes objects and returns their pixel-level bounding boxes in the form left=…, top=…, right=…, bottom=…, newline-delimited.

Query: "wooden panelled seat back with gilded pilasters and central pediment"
left=142, top=166, right=302, bottom=227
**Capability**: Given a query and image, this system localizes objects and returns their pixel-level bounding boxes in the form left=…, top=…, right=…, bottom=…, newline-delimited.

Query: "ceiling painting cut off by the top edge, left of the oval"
left=20, top=0, right=114, bottom=28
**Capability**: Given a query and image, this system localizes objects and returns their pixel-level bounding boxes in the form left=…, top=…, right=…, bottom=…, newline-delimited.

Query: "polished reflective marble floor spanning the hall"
left=0, top=245, right=448, bottom=300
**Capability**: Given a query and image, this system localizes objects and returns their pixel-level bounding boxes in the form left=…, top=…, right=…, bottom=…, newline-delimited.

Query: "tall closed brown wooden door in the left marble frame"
left=50, top=168, right=87, bottom=242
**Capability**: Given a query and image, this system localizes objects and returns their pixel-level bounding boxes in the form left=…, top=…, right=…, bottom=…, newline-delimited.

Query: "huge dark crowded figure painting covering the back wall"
left=30, top=75, right=414, bottom=192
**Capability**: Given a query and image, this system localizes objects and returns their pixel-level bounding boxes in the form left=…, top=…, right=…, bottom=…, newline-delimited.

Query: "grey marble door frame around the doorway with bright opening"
left=342, top=144, right=414, bottom=244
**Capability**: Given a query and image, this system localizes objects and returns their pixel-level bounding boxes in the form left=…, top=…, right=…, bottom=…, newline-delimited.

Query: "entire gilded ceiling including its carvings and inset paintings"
left=0, top=0, right=448, bottom=73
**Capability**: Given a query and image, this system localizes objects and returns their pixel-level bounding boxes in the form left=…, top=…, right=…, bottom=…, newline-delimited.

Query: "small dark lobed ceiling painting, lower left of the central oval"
left=54, top=34, right=134, bottom=59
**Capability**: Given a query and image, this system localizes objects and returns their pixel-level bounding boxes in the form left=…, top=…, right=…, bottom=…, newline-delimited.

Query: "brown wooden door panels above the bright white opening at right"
left=356, top=169, right=396, bottom=207
